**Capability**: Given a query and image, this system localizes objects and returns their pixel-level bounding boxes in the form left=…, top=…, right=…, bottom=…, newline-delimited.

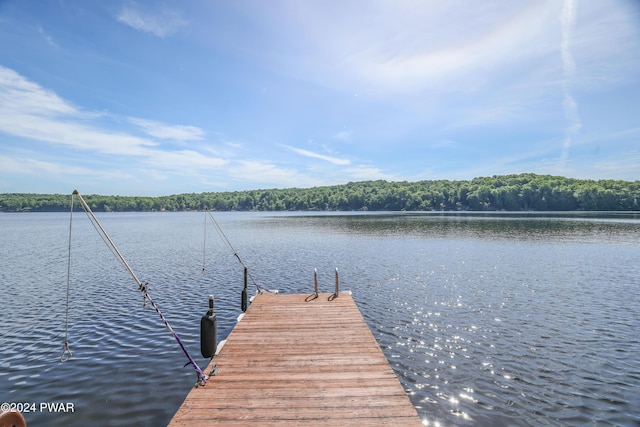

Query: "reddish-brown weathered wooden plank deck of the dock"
left=169, top=293, right=422, bottom=426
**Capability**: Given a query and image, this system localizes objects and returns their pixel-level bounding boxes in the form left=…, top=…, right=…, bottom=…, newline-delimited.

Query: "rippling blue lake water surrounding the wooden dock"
left=0, top=212, right=640, bottom=426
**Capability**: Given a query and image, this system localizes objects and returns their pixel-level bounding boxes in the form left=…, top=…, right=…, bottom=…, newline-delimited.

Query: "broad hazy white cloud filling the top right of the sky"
left=225, top=0, right=638, bottom=105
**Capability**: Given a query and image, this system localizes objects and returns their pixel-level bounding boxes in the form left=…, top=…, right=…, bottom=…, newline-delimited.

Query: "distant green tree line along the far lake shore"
left=0, top=174, right=640, bottom=212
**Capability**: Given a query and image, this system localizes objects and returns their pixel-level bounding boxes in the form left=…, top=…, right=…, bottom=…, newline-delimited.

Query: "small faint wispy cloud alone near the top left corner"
left=116, top=2, right=188, bottom=38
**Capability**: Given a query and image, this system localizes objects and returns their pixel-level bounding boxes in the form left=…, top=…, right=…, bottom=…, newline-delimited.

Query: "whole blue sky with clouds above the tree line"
left=0, top=0, right=640, bottom=196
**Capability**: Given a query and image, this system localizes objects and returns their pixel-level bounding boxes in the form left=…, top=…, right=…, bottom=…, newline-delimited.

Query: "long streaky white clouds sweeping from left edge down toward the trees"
left=0, top=66, right=330, bottom=192
